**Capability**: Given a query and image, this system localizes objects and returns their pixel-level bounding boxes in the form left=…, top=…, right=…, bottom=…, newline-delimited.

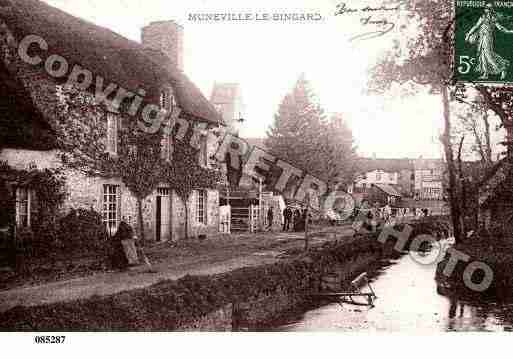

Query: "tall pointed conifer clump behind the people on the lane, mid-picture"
left=266, top=75, right=356, bottom=194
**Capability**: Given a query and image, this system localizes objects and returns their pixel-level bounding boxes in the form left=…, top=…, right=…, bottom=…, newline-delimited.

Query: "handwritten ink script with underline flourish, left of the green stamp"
left=335, top=0, right=406, bottom=41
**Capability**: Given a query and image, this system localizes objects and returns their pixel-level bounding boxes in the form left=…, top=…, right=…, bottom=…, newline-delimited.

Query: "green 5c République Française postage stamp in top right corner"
left=454, top=0, right=513, bottom=84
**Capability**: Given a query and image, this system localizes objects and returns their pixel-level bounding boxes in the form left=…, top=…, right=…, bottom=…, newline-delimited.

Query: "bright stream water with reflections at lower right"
left=264, top=243, right=513, bottom=333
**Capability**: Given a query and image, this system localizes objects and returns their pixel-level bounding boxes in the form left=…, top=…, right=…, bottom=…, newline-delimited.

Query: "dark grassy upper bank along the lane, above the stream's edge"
left=0, top=237, right=383, bottom=331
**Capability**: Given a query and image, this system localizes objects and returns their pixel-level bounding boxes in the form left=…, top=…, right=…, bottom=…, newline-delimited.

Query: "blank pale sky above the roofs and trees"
left=45, top=0, right=442, bottom=157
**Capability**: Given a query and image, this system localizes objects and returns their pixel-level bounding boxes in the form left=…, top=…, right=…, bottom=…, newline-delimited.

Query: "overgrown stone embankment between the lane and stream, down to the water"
left=0, top=223, right=448, bottom=331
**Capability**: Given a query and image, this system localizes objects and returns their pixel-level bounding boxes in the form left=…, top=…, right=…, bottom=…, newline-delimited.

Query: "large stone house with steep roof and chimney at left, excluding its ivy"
left=0, top=0, right=223, bottom=241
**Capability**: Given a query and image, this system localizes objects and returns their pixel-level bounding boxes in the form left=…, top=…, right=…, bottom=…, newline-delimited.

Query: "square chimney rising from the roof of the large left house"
left=141, top=20, right=183, bottom=71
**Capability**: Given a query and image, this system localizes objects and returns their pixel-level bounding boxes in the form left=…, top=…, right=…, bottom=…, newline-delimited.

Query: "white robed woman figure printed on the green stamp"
left=465, top=4, right=513, bottom=80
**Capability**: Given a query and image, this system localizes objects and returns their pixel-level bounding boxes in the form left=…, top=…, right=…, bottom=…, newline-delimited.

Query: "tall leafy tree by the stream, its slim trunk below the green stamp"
left=369, top=0, right=513, bottom=241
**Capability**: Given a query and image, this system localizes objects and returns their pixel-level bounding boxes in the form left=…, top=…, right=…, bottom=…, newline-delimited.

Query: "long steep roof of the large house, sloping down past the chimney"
left=0, top=0, right=222, bottom=123
